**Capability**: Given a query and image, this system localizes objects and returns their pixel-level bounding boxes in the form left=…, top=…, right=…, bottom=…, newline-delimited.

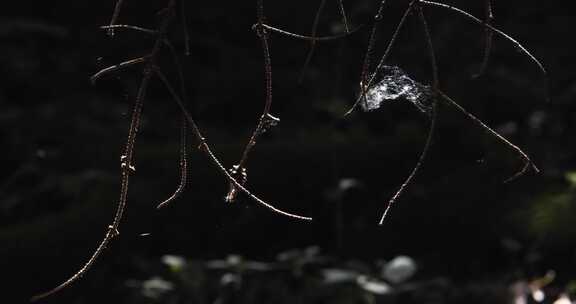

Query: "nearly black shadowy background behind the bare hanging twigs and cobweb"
left=0, top=0, right=576, bottom=303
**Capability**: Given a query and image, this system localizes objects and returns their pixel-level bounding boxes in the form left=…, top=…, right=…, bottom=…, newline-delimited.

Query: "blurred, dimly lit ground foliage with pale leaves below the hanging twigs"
left=118, top=247, right=570, bottom=304
